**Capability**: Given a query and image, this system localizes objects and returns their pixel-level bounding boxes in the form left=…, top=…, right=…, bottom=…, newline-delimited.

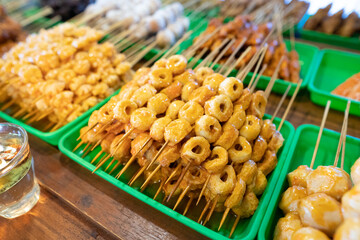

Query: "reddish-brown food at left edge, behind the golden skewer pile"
left=0, top=6, right=26, bottom=56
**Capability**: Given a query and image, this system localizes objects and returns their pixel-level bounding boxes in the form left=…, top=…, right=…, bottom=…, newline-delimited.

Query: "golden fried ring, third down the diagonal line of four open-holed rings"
left=195, top=115, right=222, bottom=143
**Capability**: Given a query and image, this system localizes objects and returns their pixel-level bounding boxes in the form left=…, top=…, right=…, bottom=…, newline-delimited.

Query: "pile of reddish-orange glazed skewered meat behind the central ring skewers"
left=195, top=16, right=300, bottom=83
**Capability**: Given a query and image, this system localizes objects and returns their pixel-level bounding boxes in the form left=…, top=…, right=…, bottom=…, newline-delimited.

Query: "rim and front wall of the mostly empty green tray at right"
left=308, top=49, right=360, bottom=116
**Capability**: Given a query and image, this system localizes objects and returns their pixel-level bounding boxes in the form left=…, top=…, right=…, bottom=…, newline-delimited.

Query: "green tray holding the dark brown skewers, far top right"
left=297, top=15, right=360, bottom=50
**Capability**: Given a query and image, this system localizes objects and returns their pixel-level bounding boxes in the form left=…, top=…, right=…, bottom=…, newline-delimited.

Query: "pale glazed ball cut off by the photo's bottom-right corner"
left=334, top=218, right=360, bottom=240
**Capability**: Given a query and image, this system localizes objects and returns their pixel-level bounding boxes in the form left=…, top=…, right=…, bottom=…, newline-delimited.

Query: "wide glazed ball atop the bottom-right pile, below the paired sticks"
left=306, top=166, right=352, bottom=200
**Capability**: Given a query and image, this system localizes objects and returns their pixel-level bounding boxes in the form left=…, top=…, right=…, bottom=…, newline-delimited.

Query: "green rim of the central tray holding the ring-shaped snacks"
left=59, top=114, right=295, bottom=240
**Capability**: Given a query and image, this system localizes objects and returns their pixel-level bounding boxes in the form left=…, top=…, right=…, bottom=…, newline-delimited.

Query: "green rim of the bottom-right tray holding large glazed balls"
left=258, top=124, right=360, bottom=240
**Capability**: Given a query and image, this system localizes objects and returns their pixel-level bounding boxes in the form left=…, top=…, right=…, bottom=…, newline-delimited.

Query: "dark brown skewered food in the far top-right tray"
left=304, top=4, right=360, bottom=37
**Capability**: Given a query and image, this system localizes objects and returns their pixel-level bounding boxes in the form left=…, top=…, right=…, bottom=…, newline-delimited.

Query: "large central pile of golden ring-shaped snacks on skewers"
left=74, top=50, right=284, bottom=236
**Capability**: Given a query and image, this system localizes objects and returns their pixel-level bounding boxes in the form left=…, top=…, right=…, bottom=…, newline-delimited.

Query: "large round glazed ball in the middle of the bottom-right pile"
left=298, top=193, right=343, bottom=237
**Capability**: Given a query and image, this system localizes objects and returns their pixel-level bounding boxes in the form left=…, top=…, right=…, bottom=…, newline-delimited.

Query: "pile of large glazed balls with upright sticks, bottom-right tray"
left=274, top=101, right=360, bottom=240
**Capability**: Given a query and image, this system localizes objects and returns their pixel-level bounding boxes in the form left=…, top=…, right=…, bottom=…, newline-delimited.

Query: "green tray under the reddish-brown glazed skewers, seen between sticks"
left=179, top=15, right=318, bottom=95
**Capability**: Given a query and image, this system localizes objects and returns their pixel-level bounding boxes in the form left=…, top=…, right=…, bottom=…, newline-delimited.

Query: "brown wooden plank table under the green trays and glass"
left=0, top=40, right=360, bottom=240
